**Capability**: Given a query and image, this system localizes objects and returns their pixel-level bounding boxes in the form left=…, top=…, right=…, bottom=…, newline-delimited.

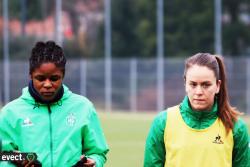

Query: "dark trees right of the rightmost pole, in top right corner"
left=223, top=0, right=250, bottom=56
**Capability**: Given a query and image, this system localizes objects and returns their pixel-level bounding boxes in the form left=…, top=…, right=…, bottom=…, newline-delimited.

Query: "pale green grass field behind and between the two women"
left=98, top=112, right=250, bottom=167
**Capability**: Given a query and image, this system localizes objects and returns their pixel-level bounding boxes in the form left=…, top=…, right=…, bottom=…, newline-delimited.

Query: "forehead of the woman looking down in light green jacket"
left=33, top=63, right=62, bottom=75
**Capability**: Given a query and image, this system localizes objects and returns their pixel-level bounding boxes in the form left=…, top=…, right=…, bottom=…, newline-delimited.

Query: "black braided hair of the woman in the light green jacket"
left=29, top=41, right=66, bottom=75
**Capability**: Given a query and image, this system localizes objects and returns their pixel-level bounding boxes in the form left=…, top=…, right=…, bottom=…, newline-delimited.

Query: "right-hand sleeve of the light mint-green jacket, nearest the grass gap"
left=83, top=106, right=109, bottom=167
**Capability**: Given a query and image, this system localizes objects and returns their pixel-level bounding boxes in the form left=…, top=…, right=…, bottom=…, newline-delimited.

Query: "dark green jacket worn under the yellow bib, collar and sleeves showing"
left=144, top=96, right=250, bottom=167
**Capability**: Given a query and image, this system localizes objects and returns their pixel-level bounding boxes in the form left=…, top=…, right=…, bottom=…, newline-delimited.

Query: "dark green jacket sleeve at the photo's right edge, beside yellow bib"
left=233, top=119, right=250, bottom=167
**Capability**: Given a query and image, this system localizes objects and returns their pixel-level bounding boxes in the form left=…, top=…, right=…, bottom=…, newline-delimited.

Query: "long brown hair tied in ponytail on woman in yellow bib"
left=184, top=53, right=242, bottom=132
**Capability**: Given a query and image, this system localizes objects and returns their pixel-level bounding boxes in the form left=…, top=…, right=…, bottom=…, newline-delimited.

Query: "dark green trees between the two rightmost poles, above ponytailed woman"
left=164, top=0, right=214, bottom=57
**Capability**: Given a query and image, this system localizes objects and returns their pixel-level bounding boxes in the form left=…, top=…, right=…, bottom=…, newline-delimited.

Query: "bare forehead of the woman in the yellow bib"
left=186, top=65, right=216, bottom=82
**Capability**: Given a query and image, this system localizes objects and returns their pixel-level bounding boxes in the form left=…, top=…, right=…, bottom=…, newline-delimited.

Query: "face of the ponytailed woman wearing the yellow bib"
left=185, top=65, right=221, bottom=111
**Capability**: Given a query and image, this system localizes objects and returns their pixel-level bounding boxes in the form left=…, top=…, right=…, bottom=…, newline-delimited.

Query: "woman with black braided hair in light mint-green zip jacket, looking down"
left=0, top=41, right=109, bottom=167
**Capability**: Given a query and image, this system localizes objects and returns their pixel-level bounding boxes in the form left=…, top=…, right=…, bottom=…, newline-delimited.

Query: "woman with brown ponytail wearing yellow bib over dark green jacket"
left=144, top=53, right=250, bottom=167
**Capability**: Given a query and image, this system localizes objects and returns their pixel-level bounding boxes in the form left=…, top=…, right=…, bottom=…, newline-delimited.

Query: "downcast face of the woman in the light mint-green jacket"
left=30, top=63, right=63, bottom=100
